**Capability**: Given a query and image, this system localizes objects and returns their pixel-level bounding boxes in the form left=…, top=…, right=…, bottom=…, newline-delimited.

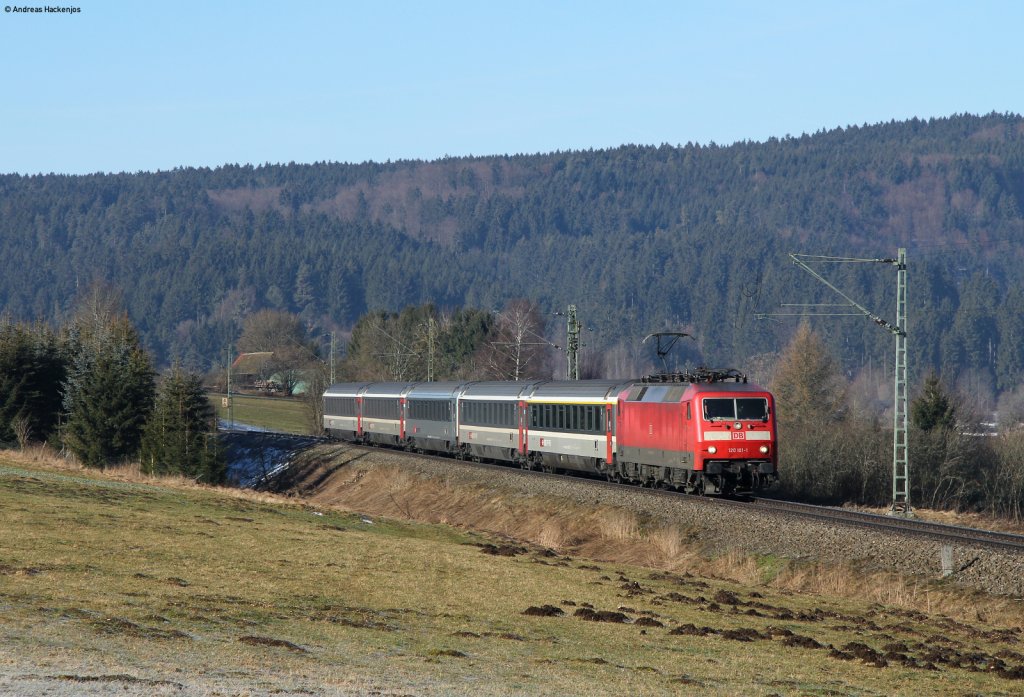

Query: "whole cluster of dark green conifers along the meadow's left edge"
left=0, top=290, right=226, bottom=483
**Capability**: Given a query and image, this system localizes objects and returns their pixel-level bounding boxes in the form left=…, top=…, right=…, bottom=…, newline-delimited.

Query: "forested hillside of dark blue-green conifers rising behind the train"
left=0, top=115, right=1024, bottom=403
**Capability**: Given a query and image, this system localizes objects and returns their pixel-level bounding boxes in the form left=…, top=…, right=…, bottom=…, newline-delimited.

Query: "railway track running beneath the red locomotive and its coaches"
left=232, top=433, right=1024, bottom=554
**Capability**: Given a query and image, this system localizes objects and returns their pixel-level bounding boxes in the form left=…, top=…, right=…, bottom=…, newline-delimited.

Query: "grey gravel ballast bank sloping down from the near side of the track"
left=284, top=445, right=1024, bottom=597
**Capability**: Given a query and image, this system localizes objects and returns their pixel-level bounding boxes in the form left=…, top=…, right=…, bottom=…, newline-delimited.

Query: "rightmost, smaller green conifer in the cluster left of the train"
left=141, top=365, right=225, bottom=483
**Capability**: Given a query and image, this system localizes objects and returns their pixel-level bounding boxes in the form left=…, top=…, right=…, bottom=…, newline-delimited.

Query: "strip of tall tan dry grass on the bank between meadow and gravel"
left=278, top=447, right=1024, bottom=626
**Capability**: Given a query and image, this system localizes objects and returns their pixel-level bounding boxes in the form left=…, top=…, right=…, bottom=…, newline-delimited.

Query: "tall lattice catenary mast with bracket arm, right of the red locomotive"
left=760, top=248, right=913, bottom=518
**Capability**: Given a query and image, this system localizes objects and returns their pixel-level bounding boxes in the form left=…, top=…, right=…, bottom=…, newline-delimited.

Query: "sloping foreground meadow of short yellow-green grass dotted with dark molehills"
left=0, top=453, right=1024, bottom=695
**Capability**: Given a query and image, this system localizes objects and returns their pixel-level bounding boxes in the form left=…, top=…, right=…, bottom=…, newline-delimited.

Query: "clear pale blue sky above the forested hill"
left=0, top=0, right=1024, bottom=174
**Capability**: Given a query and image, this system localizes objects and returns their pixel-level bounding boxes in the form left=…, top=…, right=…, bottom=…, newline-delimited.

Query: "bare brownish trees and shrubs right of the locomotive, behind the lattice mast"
left=768, top=323, right=1024, bottom=522
